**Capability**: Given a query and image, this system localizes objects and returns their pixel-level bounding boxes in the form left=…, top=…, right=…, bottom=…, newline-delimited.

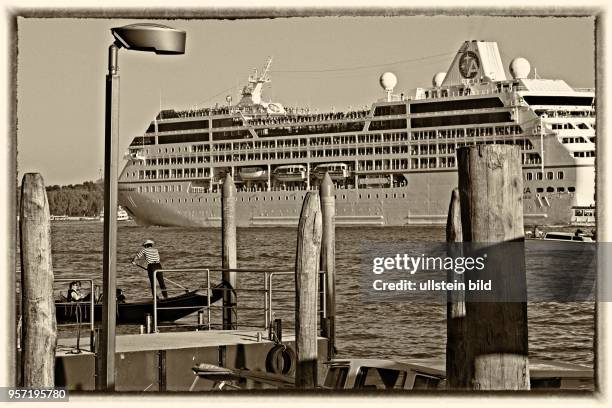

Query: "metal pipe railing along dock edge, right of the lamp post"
left=152, top=268, right=326, bottom=332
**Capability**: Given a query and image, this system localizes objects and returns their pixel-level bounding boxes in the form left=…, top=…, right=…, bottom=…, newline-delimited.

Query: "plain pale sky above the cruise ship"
left=17, top=16, right=595, bottom=185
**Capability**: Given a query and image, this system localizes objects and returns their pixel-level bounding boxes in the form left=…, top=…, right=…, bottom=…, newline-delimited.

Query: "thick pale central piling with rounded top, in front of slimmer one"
left=295, top=192, right=322, bottom=388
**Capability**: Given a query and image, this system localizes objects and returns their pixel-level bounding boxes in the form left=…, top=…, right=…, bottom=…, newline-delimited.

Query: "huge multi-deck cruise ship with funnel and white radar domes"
left=119, top=41, right=596, bottom=227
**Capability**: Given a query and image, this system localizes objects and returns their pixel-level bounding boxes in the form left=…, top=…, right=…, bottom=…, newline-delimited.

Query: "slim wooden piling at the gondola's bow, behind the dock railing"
left=221, top=173, right=238, bottom=330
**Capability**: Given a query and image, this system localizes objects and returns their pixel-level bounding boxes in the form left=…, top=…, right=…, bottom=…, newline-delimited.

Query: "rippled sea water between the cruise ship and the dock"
left=23, top=221, right=595, bottom=367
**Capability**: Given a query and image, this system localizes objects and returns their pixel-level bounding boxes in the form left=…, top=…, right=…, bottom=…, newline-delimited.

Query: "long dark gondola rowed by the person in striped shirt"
left=55, top=284, right=224, bottom=324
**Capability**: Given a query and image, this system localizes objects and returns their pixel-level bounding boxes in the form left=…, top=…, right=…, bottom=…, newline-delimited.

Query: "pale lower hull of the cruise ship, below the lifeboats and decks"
left=119, top=171, right=577, bottom=227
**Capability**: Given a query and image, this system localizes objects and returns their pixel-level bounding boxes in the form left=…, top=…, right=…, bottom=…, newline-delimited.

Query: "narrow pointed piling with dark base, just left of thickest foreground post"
left=446, top=189, right=469, bottom=389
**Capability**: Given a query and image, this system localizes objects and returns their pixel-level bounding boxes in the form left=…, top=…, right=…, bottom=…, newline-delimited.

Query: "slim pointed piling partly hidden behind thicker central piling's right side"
left=319, top=172, right=336, bottom=359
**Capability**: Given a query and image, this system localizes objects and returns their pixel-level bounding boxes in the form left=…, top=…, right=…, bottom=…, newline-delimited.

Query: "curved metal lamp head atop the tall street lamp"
left=111, top=23, right=187, bottom=54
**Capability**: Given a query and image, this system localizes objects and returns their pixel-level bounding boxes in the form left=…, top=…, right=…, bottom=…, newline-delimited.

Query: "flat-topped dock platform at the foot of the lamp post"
left=55, top=330, right=327, bottom=391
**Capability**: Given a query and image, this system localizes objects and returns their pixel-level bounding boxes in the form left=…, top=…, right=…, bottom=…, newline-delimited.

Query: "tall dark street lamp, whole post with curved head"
left=96, top=24, right=186, bottom=391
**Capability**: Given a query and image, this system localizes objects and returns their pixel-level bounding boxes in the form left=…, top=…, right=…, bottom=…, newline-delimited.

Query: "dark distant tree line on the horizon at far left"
left=17, top=181, right=104, bottom=217
